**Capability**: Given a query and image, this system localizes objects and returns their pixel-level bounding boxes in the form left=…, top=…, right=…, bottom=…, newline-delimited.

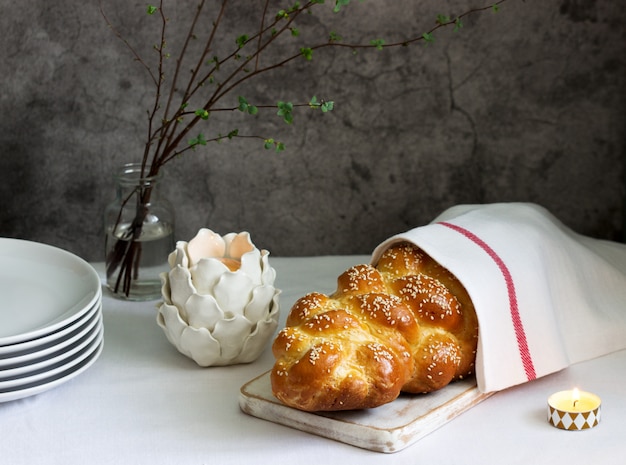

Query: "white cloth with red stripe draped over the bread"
left=372, top=203, right=626, bottom=392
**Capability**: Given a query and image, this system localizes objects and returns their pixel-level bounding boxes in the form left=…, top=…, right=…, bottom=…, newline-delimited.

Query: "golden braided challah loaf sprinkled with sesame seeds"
left=271, top=243, right=478, bottom=411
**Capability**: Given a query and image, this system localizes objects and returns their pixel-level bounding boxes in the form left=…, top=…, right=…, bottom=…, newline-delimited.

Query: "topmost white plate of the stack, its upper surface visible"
left=0, top=238, right=102, bottom=346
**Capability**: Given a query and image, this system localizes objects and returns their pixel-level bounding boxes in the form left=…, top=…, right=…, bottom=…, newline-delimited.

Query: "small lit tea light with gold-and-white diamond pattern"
left=548, top=389, right=601, bottom=431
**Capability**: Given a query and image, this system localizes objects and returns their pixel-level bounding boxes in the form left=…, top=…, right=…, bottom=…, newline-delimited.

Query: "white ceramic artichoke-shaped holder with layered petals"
left=157, top=229, right=280, bottom=367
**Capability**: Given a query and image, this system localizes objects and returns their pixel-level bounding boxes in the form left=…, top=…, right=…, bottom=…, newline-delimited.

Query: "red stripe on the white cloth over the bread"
left=439, top=222, right=537, bottom=381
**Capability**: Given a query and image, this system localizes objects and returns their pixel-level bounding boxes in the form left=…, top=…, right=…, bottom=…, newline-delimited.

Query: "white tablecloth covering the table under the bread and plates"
left=0, top=256, right=626, bottom=465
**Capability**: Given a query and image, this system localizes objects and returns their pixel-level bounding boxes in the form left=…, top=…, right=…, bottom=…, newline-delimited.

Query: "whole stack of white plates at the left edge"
left=0, top=238, right=103, bottom=402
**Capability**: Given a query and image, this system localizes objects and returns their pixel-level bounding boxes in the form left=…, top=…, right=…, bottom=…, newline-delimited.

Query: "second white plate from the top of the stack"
left=0, top=300, right=102, bottom=364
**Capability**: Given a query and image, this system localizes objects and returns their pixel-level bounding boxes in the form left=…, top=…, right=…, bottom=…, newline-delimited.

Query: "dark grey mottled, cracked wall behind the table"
left=0, top=0, right=626, bottom=260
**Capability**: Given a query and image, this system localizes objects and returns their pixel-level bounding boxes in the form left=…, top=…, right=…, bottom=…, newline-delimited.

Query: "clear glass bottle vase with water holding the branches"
left=104, top=163, right=175, bottom=300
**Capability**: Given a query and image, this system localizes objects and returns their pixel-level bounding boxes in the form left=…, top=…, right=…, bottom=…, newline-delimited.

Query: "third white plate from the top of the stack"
left=0, top=313, right=102, bottom=376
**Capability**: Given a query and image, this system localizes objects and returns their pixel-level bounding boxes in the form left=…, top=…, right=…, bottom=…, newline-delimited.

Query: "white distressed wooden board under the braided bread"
left=239, top=372, right=492, bottom=453
